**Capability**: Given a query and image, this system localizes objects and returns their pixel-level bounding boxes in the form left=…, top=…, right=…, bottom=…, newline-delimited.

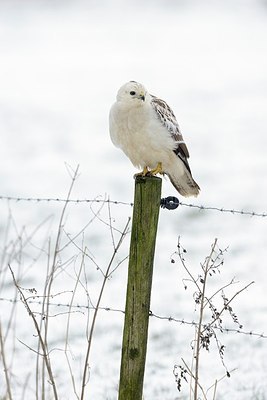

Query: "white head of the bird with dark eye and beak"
left=117, top=81, right=148, bottom=106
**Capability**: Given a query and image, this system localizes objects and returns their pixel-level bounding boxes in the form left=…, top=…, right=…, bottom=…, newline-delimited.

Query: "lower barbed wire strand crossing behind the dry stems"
left=0, top=296, right=267, bottom=339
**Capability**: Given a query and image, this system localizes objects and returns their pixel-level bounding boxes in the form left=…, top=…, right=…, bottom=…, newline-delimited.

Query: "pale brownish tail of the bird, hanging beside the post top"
left=166, top=167, right=200, bottom=197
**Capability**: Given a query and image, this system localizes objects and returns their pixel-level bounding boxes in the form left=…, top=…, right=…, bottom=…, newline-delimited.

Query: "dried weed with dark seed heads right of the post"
left=176, top=238, right=254, bottom=400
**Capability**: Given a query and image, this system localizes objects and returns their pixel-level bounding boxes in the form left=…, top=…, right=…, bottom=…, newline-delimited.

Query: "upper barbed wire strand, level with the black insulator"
left=0, top=196, right=267, bottom=218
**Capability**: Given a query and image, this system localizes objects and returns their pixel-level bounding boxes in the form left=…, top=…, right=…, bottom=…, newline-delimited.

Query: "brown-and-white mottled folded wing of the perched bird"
left=151, top=95, right=191, bottom=172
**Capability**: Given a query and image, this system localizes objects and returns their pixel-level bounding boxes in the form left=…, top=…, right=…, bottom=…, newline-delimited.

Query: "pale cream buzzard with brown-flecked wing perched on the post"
left=109, top=81, right=200, bottom=197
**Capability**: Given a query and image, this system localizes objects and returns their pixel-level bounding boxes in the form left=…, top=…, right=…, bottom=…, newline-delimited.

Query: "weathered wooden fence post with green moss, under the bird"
left=119, top=176, right=161, bottom=400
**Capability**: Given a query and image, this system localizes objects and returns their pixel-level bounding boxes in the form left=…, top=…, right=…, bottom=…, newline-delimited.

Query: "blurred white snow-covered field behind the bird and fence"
left=0, top=0, right=267, bottom=400
